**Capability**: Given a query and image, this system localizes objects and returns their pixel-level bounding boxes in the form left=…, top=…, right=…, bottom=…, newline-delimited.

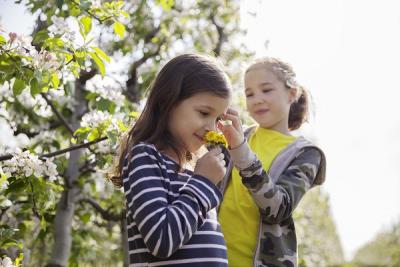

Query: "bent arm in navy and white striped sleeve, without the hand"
left=123, top=144, right=222, bottom=258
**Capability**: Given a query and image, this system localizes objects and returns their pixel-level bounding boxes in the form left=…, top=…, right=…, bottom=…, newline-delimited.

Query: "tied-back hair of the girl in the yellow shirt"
left=245, top=57, right=309, bottom=131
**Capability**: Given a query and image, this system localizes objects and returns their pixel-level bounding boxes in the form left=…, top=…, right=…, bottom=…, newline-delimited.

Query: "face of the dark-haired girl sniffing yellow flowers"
left=168, top=92, right=230, bottom=156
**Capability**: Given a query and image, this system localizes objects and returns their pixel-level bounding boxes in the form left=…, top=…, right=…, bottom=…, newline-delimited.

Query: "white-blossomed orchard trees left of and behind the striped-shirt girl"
left=0, top=0, right=250, bottom=266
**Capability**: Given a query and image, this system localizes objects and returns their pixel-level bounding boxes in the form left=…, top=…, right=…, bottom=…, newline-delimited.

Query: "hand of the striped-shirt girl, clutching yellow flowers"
left=194, top=147, right=226, bottom=184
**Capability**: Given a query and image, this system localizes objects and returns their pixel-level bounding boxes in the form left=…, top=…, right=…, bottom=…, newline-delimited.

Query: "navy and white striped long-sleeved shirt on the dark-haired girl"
left=122, top=143, right=228, bottom=267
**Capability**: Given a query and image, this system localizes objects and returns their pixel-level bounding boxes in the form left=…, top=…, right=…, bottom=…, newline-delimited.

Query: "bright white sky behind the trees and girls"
left=0, top=0, right=400, bottom=259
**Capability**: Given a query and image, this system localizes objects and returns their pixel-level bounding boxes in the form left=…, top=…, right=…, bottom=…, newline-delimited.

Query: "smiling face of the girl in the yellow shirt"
left=245, top=66, right=296, bottom=134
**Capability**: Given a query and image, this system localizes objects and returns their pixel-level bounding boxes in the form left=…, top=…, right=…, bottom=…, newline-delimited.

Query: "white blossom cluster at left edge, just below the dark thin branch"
left=3, top=151, right=58, bottom=182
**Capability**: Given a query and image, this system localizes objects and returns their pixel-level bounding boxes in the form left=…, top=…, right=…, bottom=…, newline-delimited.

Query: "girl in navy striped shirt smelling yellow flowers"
left=112, top=54, right=231, bottom=267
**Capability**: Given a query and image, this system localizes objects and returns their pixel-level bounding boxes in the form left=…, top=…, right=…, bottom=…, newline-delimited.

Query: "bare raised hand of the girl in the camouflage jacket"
left=217, top=108, right=244, bottom=149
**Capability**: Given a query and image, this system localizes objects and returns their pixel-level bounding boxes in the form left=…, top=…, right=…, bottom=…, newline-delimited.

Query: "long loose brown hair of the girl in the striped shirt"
left=109, top=54, right=231, bottom=186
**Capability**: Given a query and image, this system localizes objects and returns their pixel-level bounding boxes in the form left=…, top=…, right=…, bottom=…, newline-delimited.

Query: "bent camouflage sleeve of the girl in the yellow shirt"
left=234, top=148, right=321, bottom=224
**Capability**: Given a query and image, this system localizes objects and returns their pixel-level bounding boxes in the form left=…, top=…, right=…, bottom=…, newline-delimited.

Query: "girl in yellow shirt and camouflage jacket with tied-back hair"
left=218, top=58, right=325, bottom=267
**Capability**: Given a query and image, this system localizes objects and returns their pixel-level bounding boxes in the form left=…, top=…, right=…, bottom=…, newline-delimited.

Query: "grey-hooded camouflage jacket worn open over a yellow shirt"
left=220, top=129, right=326, bottom=267
